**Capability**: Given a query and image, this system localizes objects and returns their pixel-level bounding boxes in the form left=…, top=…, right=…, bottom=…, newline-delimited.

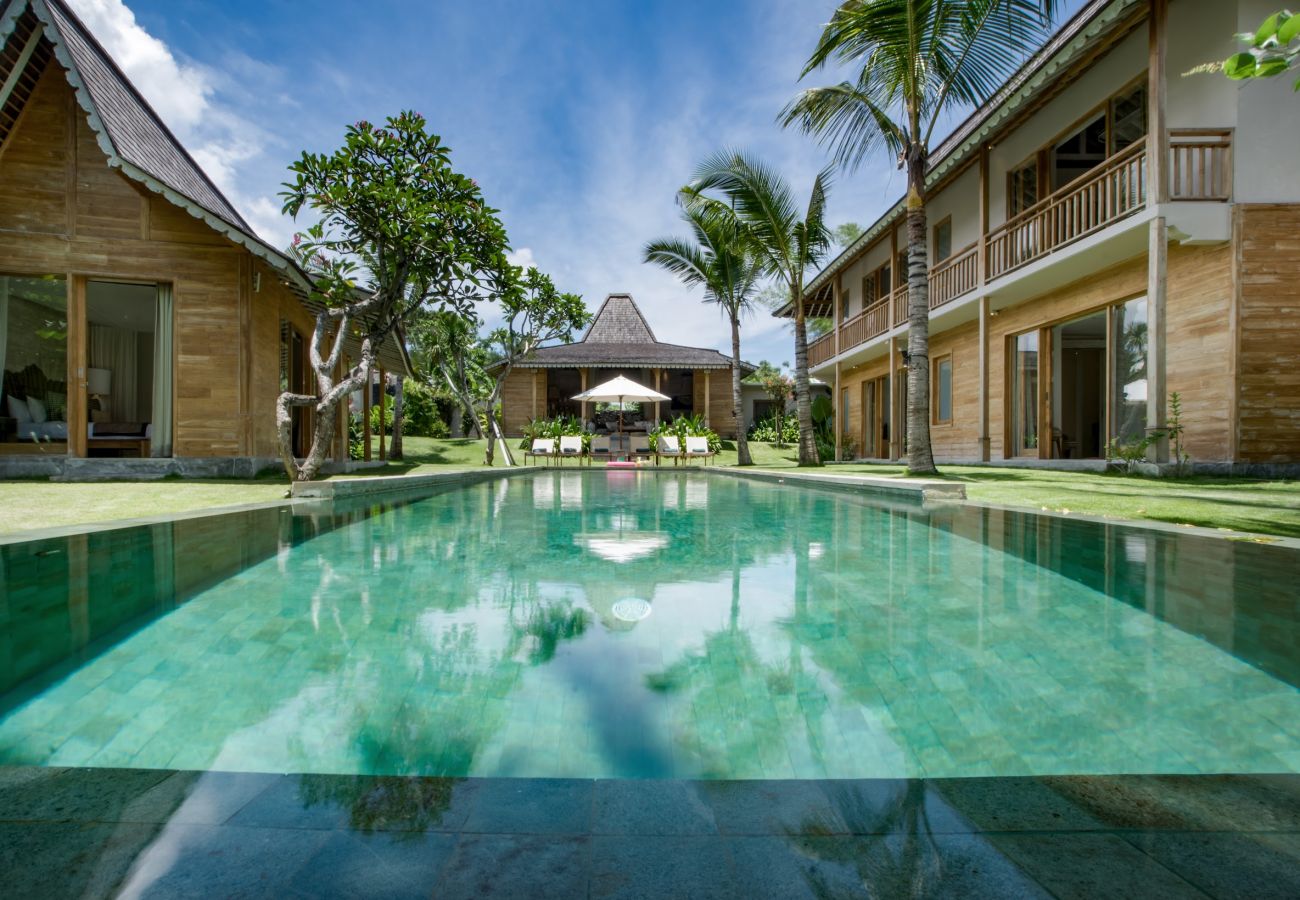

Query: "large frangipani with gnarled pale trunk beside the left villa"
left=276, top=112, right=508, bottom=481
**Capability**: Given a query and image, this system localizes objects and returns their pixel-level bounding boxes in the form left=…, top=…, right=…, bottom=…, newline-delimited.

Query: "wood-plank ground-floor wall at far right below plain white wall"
left=1236, top=204, right=1300, bottom=463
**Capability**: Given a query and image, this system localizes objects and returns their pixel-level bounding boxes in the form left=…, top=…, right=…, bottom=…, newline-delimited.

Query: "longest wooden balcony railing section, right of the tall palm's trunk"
left=987, top=140, right=1147, bottom=280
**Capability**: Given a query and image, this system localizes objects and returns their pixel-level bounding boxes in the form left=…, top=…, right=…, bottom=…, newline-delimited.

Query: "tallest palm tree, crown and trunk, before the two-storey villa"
left=781, top=0, right=1057, bottom=473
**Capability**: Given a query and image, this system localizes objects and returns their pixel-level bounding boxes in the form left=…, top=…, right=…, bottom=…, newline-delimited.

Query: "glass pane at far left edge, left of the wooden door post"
left=0, top=274, right=68, bottom=453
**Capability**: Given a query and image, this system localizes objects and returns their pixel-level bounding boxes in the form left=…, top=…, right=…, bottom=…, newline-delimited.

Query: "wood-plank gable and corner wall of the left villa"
left=0, top=65, right=312, bottom=457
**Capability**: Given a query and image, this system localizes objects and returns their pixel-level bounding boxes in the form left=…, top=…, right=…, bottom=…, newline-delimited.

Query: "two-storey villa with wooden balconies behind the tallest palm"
left=787, top=0, right=1300, bottom=471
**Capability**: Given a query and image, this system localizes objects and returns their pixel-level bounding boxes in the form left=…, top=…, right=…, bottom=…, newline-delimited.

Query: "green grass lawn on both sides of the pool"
left=0, top=437, right=1300, bottom=537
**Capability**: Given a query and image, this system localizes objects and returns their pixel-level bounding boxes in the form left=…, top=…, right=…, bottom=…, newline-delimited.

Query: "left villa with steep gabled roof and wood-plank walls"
left=0, top=0, right=404, bottom=475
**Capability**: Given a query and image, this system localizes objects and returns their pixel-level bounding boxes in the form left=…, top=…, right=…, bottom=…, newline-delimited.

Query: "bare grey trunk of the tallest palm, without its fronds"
left=907, top=150, right=939, bottom=475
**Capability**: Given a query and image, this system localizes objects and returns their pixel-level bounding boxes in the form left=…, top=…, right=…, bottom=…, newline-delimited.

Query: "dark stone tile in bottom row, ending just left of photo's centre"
left=433, top=835, right=592, bottom=900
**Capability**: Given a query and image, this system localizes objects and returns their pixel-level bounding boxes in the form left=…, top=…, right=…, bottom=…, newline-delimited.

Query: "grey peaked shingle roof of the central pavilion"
left=506, top=294, right=755, bottom=373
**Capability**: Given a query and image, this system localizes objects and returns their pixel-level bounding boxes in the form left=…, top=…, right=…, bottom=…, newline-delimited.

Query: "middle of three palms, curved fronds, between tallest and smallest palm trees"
left=681, top=151, right=831, bottom=466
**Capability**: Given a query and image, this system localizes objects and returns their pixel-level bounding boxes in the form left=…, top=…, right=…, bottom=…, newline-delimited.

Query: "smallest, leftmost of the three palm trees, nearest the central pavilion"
left=645, top=207, right=762, bottom=466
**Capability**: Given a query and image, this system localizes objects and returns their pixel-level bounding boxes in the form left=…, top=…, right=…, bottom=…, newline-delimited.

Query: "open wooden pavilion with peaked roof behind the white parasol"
left=502, top=294, right=754, bottom=437
